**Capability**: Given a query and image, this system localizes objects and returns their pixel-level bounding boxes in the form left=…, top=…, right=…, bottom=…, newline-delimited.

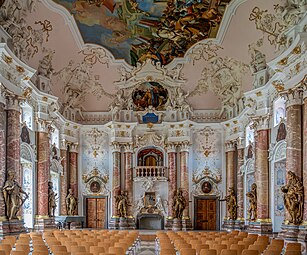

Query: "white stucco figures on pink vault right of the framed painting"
left=194, top=57, right=248, bottom=116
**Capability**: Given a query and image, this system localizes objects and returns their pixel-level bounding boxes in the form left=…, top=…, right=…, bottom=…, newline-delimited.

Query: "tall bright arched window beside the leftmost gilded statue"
left=20, top=142, right=36, bottom=229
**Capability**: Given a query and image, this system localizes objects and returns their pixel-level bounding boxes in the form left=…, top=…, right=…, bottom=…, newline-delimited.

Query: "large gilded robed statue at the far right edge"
left=281, top=171, right=304, bottom=225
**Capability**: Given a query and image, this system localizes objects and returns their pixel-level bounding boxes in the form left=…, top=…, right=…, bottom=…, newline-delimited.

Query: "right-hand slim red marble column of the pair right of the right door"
left=237, top=142, right=244, bottom=220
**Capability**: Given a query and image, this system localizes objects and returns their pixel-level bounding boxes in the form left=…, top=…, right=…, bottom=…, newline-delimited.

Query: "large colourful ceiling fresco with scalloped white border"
left=53, top=0, right=231, bottom=66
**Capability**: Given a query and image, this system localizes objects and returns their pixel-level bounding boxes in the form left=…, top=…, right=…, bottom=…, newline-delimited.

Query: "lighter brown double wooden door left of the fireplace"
left=86, top=198, right=107, bottom=229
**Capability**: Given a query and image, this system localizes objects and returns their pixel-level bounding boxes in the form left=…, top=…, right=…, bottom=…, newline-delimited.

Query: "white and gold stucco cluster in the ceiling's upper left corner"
left=0, top=0, right=53, bottom=59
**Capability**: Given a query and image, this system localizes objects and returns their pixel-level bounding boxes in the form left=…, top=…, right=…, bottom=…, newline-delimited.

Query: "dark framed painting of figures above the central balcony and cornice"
left=132, top=81, right=168, bottom=111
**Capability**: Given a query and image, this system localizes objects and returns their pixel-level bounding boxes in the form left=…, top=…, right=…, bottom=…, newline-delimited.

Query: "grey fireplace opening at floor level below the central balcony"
left=137, top=213, right=164, bottom=230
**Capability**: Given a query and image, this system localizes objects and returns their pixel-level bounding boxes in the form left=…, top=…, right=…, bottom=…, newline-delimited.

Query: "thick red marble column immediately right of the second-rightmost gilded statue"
left=255, top=129, right=270, bottom=219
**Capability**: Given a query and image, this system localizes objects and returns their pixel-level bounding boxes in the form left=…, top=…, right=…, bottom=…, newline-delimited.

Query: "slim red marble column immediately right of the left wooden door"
left=112, top=143, right=121, bottom=216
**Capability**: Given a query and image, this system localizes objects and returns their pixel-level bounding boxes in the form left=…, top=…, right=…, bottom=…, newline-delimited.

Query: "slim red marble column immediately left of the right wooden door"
left=180, top=144, right=190, bottom=217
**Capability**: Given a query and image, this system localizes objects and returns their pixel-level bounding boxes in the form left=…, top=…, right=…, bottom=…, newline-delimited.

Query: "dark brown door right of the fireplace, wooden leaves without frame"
left=195, top=199, right=216, bottom=230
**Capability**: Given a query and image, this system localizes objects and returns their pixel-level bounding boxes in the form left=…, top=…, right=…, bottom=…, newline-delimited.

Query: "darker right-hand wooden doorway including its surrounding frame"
left=194, top=196, right=219, bottom=230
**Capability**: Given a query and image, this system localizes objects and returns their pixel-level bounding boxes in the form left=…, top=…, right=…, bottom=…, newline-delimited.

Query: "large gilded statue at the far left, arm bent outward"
left=2, top=170, right=29, bottom=220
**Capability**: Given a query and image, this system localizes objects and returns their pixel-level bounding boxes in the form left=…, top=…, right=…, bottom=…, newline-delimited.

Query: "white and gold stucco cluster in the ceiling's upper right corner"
left=249, top=0, right=307, bottom=49
